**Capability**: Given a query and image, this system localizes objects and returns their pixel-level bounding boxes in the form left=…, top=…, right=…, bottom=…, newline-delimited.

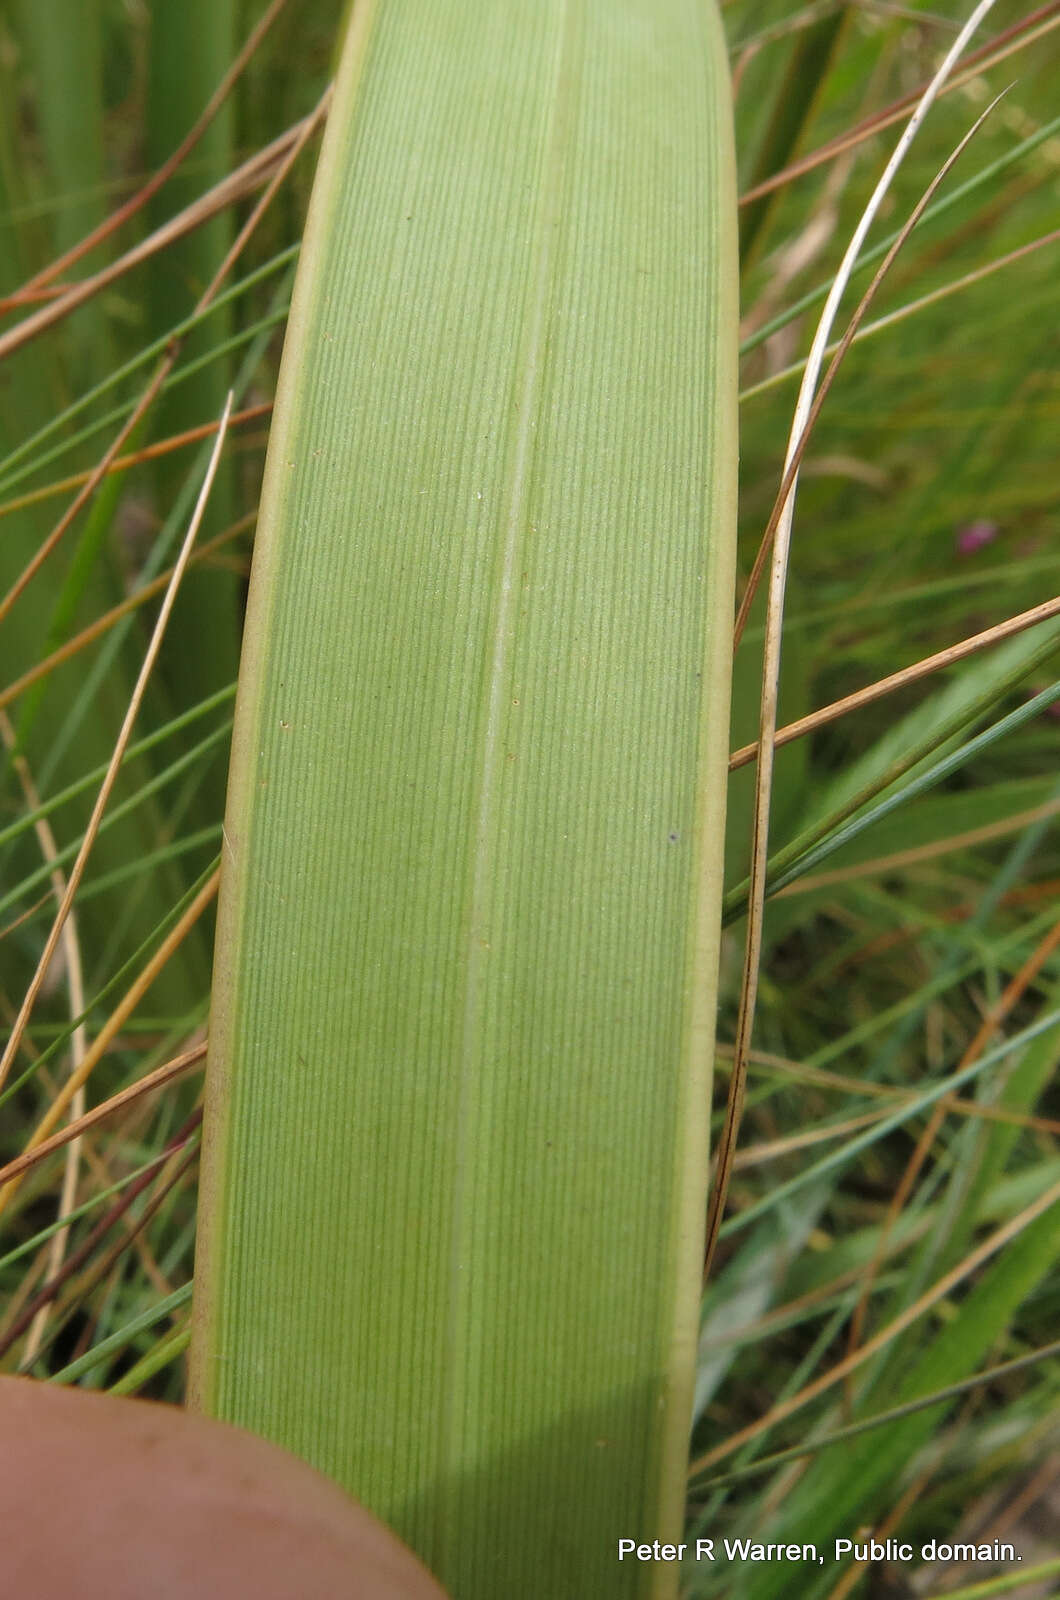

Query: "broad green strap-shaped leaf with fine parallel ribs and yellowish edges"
left=194, top=0, right=737, bottom=1600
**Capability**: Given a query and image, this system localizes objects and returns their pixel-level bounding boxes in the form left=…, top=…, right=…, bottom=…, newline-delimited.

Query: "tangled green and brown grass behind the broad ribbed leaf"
left=0, top=0, right=1060, bottom=1600
